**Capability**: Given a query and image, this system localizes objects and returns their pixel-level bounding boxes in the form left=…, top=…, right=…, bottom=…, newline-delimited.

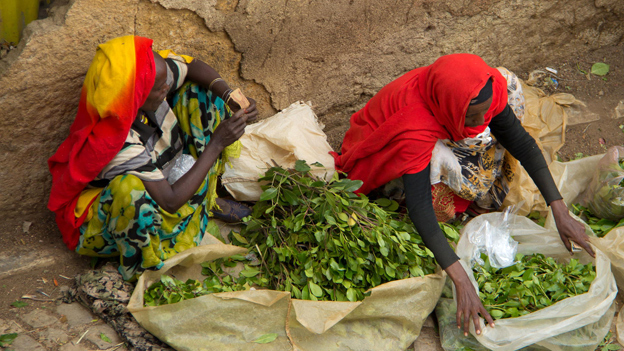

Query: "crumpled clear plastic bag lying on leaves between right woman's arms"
left=468, top=206, right=518, bottom=268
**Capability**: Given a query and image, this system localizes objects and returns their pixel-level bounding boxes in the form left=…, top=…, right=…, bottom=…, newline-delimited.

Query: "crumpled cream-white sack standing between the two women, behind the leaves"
left=221, top=101, right=335, bottom=201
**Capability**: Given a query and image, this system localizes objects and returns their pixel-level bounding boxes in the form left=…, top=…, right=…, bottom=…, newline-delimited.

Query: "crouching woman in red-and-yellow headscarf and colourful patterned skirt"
left=48, top=36, right=258, bottom=279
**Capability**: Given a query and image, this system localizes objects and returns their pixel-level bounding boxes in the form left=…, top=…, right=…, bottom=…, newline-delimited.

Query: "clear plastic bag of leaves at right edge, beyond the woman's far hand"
left=582, top=146, right=624, bottom=221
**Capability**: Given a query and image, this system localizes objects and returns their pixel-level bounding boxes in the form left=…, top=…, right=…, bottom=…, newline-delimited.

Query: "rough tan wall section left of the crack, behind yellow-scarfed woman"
left=0, top=0, right=275, bottom=220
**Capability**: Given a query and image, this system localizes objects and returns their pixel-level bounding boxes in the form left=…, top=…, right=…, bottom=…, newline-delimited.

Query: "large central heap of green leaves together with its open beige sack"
left=128, top=163, right=445, bottom=351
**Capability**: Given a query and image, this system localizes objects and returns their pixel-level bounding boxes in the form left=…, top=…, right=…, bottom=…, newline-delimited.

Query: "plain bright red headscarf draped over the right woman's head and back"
left=332, top=54, right=507, bottom=194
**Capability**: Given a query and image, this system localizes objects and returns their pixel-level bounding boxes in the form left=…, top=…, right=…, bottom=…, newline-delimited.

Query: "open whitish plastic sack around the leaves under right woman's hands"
left=450, top=213, right=617, bottom=351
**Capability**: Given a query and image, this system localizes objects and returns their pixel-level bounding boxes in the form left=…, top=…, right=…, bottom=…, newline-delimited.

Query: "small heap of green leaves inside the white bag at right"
left=473, top=254, right=596, bottom=319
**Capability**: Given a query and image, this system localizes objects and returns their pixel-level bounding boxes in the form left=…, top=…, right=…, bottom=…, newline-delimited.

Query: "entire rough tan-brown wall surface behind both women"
left=0, top=0, right=624, bottom=226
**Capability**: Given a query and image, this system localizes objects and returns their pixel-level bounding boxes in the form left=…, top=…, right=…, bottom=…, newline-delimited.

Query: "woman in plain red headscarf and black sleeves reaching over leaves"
left=334, top=54, right=593, bottom=335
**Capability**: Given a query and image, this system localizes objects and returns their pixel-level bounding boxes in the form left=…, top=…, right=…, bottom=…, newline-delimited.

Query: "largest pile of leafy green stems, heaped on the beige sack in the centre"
left=145, top=161, right=459, bottom=305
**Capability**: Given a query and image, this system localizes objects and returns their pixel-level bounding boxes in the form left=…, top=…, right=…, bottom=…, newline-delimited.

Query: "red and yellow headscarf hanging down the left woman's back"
left=48, top=36, right=156, bottom=250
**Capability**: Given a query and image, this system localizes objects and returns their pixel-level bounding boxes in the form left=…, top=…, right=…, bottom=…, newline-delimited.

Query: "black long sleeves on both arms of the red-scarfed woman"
left=403, top=105, right=562, bottom=269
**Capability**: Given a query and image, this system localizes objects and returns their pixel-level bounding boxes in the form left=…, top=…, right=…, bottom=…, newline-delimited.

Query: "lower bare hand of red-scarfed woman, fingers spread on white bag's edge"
left=445, top=261, right=494, bottom=336
